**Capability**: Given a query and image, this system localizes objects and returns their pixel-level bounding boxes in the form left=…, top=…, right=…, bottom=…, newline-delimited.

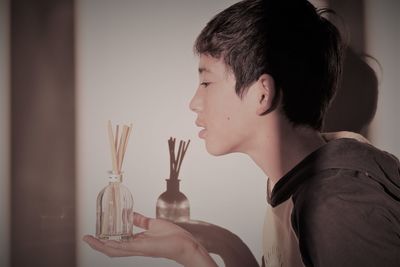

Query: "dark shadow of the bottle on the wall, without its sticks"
left=156, top=179, right=190, bottom=222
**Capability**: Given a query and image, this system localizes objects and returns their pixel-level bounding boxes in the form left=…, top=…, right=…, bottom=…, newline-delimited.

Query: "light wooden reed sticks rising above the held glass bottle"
left=108, top=121, right=132, bottom=174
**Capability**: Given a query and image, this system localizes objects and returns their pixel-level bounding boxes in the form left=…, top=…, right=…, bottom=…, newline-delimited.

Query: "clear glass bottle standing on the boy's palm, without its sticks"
left=96, top=171, right=133, bottom=240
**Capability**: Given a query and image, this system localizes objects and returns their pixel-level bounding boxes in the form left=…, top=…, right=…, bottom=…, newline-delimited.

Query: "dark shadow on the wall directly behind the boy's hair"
left=324, top=0, right=378, bottom=137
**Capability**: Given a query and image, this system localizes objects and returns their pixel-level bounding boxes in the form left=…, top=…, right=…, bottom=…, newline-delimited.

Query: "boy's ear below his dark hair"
left=256, top=74, right=277, bottom=116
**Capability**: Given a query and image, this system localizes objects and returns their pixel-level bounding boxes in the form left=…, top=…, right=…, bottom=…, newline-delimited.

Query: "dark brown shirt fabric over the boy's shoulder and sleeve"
left=268, top=138, right=400, bottom=267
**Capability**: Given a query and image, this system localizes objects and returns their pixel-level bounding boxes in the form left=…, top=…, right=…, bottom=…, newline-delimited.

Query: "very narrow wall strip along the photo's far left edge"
left=0, top=0, right=10, bottom=267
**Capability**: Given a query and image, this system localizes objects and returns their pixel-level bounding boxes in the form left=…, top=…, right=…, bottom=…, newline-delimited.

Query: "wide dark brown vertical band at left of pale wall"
left=10, top=0, right=76, bottom=267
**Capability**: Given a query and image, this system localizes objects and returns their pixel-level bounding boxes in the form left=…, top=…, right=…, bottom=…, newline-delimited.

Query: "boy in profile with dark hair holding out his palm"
left=85, top=0, right=400, bottom=266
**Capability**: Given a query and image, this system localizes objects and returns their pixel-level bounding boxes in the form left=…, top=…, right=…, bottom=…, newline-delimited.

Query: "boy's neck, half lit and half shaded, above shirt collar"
left=246, top=115, right=325, bottom=193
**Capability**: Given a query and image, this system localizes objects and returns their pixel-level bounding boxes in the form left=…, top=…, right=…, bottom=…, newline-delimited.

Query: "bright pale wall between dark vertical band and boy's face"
left=77, top=0, right=266, bottom=267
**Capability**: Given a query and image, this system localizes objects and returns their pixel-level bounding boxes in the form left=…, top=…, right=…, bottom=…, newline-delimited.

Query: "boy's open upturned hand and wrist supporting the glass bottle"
left=83, top=213, right=216, bottom=267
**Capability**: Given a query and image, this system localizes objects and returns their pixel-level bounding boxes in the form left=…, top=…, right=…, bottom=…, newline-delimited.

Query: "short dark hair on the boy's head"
left=194, top=0, right=342, bottom=130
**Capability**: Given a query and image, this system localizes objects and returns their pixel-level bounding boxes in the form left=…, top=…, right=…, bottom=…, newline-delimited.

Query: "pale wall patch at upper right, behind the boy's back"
left=365, top=0, right=400, bottom=157
